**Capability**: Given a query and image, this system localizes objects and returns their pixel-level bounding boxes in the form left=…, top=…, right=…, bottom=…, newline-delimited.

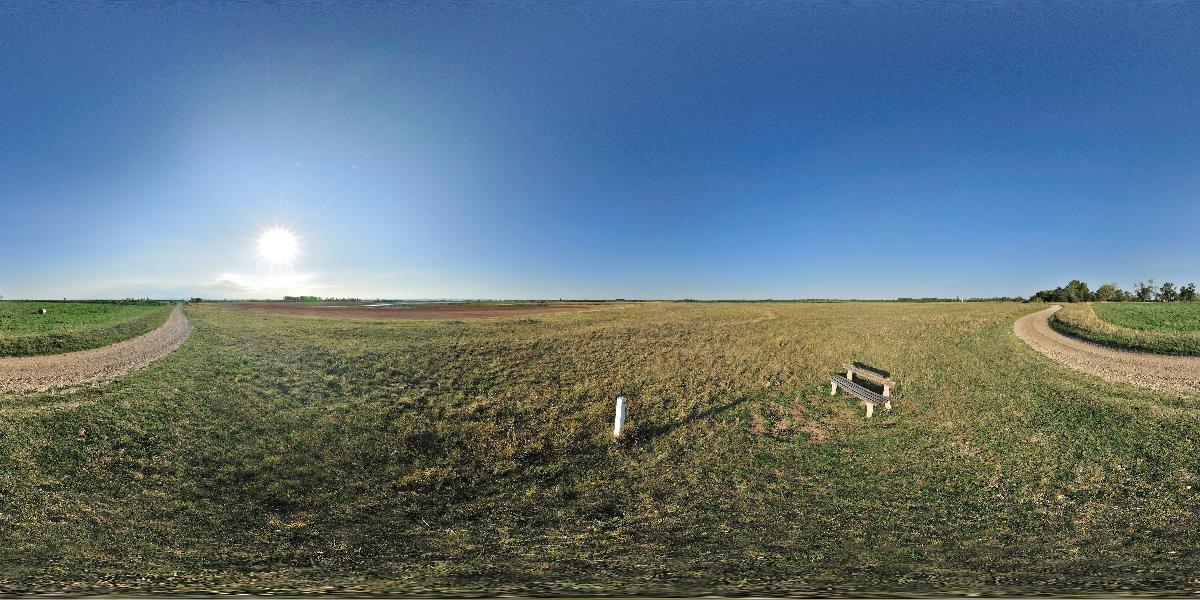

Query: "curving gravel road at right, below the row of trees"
left=1013, top=306, right=1200, bottom=394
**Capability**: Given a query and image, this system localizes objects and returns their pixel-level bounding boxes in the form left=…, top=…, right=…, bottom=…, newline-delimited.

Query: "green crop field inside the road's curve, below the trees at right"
left=1050, top=302, right=1200, bottom=355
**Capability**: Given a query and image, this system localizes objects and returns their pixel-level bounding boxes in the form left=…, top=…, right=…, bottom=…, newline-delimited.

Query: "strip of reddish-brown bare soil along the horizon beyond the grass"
left=233, top=302, right=602, bottom=319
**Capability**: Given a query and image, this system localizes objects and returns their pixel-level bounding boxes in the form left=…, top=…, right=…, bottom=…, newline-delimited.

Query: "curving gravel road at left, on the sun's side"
left=0, top=305, right=192, bottom=394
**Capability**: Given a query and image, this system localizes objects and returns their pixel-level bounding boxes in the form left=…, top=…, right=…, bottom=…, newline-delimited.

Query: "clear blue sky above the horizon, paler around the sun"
left=0, top=0, right=1200, bottom=299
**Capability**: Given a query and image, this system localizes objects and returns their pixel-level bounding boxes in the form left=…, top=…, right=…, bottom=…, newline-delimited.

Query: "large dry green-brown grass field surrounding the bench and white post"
left=0, top=304, right=1200, bottom=594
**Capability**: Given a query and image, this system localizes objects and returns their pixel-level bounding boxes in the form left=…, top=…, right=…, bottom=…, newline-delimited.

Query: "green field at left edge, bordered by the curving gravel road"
left=0, top=300, right=172, bottom=356
